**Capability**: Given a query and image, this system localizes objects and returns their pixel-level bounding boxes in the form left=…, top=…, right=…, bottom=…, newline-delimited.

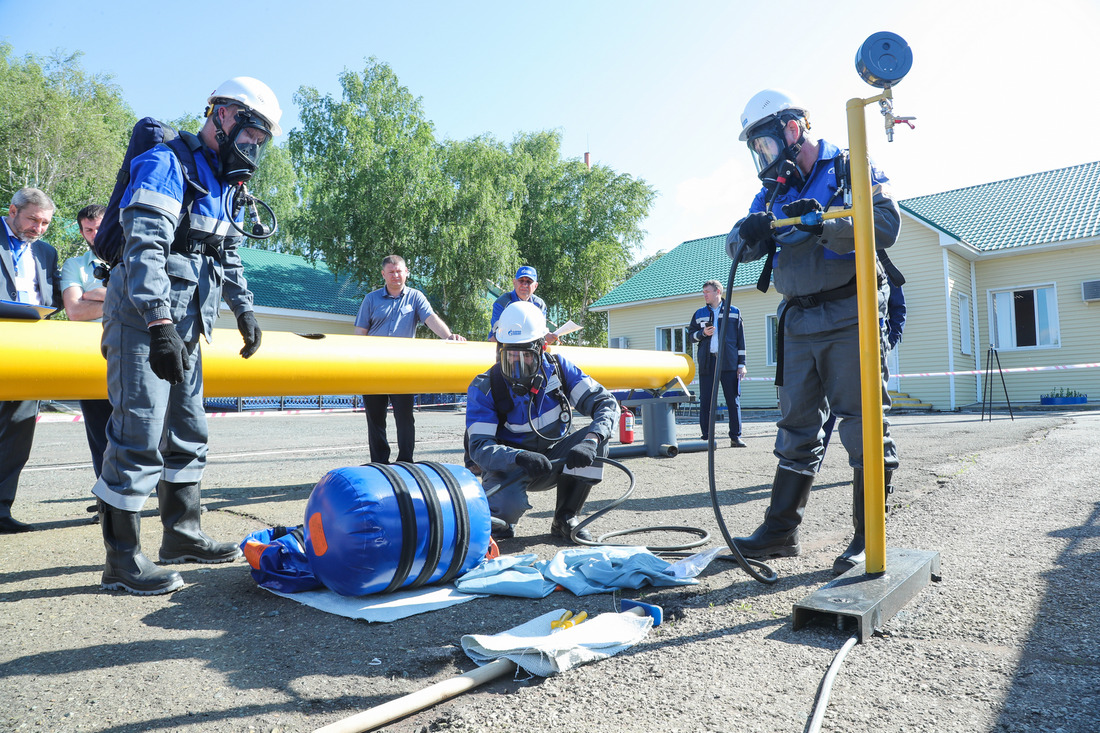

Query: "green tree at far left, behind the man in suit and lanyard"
left=0, top=44, right=134, bottom=258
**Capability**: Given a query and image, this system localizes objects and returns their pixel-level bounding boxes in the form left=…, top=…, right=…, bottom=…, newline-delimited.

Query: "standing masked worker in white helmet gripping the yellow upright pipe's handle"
left=726, top=89, right=901, bottom=573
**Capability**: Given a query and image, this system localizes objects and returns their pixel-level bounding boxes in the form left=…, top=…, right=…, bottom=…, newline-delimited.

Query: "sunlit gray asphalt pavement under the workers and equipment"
left=0, top=411, right=1100, bottom=733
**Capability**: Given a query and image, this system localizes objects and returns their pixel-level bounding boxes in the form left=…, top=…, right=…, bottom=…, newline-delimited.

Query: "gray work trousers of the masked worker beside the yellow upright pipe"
left=776, top=326, right=898, bottom=475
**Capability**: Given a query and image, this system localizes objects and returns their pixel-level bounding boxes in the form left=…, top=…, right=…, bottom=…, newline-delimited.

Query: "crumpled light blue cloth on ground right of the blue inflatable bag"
left=454, top=547, right=699, bottom=598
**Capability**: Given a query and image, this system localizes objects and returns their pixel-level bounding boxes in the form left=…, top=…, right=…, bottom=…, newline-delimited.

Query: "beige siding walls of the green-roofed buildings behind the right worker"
left=607, top=212, right=1100, bottom=411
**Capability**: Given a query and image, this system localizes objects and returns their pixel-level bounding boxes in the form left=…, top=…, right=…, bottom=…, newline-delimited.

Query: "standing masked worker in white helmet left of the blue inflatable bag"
left=92, top=76, right=283, bottom=595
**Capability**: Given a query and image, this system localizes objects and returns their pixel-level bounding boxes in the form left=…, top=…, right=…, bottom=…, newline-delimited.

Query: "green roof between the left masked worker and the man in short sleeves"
left=238, top=248, right=366, bottom=316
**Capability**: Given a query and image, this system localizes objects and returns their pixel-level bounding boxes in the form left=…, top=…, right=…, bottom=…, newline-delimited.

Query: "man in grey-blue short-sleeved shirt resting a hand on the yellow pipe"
left=355, top=254, right=466, bottom=463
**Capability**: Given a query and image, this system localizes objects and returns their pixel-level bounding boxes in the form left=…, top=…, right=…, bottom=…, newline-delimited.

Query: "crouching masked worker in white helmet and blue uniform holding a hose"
left=466, top=302, right=619, bottom=541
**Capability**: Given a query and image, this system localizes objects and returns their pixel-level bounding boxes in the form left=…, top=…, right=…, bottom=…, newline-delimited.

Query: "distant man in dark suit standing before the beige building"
left=688, top=280, right=748, bottom=448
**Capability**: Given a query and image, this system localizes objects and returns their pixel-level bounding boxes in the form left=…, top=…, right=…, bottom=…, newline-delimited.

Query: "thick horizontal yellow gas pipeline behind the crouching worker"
left=0, top=320, right=695, bottom=400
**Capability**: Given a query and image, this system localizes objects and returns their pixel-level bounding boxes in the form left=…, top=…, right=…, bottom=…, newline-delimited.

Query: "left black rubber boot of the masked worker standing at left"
left=98, top=501, right=184, bottom=595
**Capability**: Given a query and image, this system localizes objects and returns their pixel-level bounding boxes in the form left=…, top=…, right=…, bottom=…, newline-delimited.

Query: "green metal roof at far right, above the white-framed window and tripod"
left=899, top=162, right=1100, bottom=252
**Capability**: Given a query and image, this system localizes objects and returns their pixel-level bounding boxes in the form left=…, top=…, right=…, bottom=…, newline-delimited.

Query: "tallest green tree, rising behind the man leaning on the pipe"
left=289, top=58, right=451, bottom=294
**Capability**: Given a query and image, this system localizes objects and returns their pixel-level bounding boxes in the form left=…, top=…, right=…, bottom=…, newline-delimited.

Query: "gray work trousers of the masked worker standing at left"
left=91, top=319, right=209, bottom=512
